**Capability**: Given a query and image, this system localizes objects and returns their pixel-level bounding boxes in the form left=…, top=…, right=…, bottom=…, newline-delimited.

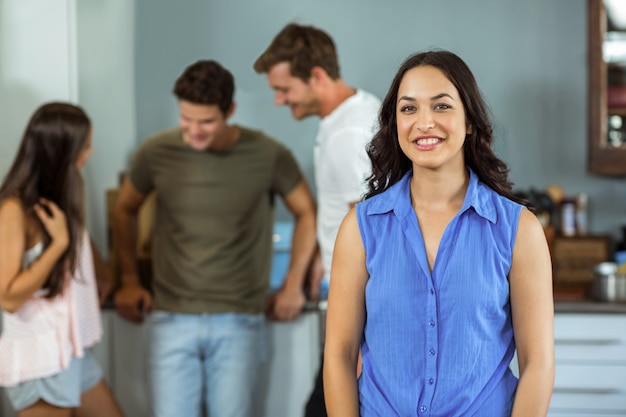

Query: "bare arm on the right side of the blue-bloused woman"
left=509, top=210, right=555, bottom=417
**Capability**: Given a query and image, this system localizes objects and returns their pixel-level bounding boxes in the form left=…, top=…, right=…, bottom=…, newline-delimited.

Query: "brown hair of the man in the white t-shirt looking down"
left=253, top=23, right=340, bottom=82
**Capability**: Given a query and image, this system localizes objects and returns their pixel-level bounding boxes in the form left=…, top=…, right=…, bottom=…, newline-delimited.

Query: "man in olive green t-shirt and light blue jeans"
left=115, top=61, right=315, bottom=417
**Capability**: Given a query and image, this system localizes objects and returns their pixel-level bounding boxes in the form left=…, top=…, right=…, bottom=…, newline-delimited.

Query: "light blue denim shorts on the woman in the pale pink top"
left=4, top=349, right=102, bottom=411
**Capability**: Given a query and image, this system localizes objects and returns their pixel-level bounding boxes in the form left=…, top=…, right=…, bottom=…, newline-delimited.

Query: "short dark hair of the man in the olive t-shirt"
left=172, top=60, right=235, bottom=114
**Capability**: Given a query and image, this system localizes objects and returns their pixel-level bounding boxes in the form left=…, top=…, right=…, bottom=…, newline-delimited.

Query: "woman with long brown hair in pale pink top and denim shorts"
left=0, top=102, right=122, bottom=417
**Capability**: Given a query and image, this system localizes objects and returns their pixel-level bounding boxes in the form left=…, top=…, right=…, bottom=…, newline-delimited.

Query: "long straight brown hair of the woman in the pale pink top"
left=0, top=102, right=91, bottom=298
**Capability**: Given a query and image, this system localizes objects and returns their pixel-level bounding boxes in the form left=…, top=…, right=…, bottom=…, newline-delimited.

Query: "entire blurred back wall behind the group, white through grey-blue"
left=0, top=0, right=626, bottom=251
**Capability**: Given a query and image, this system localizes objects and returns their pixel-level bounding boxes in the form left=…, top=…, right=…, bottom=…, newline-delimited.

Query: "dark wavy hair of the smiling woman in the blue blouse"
left=365, top=50, right=526, bottom=205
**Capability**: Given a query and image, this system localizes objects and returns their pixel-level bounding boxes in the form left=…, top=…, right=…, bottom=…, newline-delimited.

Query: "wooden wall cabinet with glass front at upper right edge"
left=587, top=0, right=626, bottom=176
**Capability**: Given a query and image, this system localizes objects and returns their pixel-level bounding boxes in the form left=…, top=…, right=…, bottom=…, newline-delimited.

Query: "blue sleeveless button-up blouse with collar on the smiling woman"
left=356, top=170, right=523, bottom=417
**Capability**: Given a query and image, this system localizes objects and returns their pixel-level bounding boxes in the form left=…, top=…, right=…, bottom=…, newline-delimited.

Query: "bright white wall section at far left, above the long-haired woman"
left=0, top=0, right=77, bottom=172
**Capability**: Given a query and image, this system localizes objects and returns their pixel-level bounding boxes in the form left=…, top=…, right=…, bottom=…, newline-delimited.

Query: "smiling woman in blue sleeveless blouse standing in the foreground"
left=324, top=50, right=554, bottom=417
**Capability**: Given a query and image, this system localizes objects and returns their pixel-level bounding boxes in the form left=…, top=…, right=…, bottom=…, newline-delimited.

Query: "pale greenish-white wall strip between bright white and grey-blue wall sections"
left=76, top=0, right=136, bottom=252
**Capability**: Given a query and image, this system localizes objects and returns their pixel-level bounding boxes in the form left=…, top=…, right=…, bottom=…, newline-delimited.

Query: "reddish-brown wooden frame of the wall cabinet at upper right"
left=587, top=0, right=626, bottom=176
